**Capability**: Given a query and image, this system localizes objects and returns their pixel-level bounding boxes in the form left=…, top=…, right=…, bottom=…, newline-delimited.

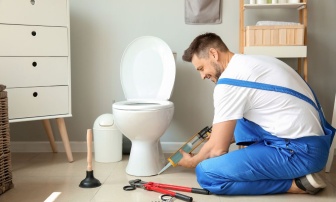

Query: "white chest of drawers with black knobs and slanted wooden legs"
left=0, top=0, right=72, bottom=161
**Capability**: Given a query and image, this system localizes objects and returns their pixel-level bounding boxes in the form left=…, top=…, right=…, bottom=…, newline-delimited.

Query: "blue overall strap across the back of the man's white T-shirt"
left=217, top=78, right=335, bottom=138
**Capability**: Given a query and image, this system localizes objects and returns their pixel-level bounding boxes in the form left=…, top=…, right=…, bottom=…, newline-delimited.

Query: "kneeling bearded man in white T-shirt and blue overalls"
left=179, top=33, right=335, bottom=195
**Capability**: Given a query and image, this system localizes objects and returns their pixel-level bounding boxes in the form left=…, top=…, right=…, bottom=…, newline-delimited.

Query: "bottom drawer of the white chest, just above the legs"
left=6, top=86, right=69, bottom=119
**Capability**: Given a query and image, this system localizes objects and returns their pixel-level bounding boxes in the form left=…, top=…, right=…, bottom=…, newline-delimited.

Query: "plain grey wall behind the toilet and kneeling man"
left=11, top=0, right=336, bottom=148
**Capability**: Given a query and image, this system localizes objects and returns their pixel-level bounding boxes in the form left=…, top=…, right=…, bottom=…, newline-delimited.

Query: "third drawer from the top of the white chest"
left=0, top=57, right=70, bottom=88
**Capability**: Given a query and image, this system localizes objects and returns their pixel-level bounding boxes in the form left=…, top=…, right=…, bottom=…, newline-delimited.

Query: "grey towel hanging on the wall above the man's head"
left=185, top=0, right=222, bottom=24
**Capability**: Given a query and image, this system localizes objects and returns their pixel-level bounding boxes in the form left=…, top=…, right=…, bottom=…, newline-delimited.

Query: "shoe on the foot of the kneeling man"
left=295, top=173, right=327, bottom=194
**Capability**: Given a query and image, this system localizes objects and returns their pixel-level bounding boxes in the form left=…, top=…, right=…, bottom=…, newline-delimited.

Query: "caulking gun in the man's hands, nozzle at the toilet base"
left=158, top=126, right=212, bottom=175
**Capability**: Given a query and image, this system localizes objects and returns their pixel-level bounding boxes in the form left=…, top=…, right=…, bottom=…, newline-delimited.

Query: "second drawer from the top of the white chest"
left=0, top=24, right=69, bottom=56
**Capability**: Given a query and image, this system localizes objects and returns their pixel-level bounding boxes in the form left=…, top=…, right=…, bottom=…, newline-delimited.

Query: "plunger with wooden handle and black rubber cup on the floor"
left=79, top=129, right=101, bottom=188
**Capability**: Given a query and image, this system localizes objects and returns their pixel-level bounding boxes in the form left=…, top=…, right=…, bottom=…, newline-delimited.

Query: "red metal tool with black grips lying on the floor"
left=123, top=179, right=210, bottom=201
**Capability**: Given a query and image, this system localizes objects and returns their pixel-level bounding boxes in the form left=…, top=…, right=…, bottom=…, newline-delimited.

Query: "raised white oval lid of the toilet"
left=120, top=36, right=176, bottom=100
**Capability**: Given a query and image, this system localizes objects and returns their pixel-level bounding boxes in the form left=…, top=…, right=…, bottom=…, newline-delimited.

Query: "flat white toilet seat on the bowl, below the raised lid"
left=113, top=100, right=174, bottom=111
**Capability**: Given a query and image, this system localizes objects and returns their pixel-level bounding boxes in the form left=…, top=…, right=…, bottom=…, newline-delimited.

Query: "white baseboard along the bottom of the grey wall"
left=10, top=141, right=237, bottom=153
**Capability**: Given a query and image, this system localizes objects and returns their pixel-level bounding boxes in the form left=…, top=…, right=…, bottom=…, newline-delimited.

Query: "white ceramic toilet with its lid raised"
left=112, top=36, right=176, bottom=176
